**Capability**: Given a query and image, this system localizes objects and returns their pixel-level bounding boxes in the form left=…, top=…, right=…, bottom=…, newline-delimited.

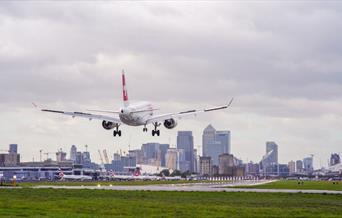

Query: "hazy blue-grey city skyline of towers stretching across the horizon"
left=0, top=127, right=340, bottom=171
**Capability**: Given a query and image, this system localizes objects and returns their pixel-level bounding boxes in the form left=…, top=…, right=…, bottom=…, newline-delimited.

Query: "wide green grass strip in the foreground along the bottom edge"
left=0, top=188, right=342, bottom=217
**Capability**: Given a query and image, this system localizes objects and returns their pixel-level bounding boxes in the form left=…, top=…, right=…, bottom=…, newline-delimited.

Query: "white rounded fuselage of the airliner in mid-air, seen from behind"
left=119, top=102, right=153, bottom=126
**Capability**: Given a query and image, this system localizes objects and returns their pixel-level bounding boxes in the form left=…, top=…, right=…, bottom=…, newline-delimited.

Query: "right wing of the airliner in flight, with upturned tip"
left=147, top=98, right=234, bottom=124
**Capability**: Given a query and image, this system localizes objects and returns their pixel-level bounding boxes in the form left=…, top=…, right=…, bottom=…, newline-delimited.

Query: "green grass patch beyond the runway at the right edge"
left=236, top=180, right=342, bottom=191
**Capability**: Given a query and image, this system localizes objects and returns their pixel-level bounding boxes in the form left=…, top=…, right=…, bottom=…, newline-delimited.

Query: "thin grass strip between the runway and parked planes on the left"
left=17, top=180, right=216, bottom=187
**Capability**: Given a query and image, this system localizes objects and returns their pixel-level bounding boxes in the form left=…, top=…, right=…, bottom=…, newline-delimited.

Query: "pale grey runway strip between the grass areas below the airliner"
left=33, top=180, right=342, bottom=194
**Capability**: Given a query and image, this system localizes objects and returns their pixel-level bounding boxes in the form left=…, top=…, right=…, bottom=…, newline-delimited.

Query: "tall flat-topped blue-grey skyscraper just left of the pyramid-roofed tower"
left=177, top=131, right=194, bottom=172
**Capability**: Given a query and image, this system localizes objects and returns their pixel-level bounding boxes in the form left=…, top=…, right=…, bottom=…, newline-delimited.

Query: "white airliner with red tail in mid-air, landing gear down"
left=32, top=70, right=233, bottom=137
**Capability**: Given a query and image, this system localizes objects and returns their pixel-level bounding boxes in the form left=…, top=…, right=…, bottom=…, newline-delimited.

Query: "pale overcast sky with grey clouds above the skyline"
left=0, top=1, right=342, bottom=167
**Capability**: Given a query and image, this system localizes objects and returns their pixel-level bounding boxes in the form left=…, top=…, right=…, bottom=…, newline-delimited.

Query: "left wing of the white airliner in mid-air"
left=33, top=103, right=121, bottom=124
